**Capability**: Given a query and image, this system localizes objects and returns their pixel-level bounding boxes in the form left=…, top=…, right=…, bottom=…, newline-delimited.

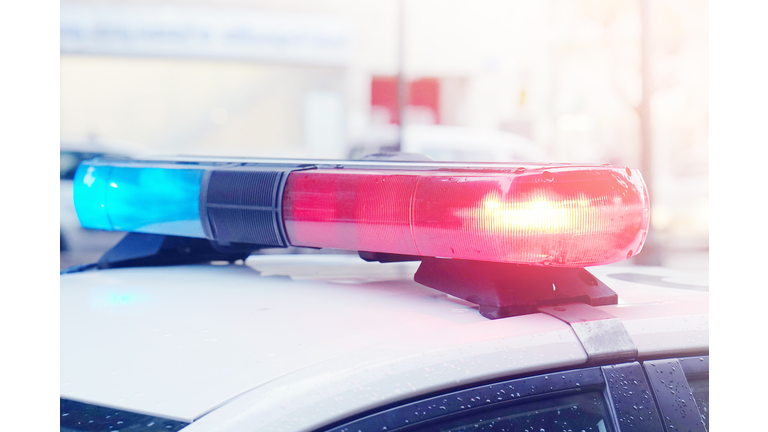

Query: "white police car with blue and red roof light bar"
left=60, top=158, right=709, bottom=432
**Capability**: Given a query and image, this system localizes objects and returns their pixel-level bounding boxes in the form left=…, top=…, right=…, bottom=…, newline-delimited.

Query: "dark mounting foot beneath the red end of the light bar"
left=414, top=257, right=618, bottom=319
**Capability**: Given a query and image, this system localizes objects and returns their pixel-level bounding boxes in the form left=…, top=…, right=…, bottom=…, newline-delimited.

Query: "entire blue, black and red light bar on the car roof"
left=74, top=158, right=650, bottom=267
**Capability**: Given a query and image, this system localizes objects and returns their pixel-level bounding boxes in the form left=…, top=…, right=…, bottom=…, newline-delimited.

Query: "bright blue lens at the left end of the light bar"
left=74, top=161, right=205, bottom=238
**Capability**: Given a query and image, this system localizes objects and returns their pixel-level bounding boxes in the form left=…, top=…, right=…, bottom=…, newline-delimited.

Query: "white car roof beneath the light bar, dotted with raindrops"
left=61, top=254, right=709, bottom=431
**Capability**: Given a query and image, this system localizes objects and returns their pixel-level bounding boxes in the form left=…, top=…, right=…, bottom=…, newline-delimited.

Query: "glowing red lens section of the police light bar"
left=283, top=166, right=649, bottom=267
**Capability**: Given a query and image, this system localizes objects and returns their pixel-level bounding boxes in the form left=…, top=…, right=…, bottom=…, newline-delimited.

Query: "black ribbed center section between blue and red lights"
left=203, top=167, right=292, bottom=247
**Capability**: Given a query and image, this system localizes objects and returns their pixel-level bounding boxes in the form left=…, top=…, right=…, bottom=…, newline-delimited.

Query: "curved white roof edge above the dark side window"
left=185, top=314, right=587, bottom=432
